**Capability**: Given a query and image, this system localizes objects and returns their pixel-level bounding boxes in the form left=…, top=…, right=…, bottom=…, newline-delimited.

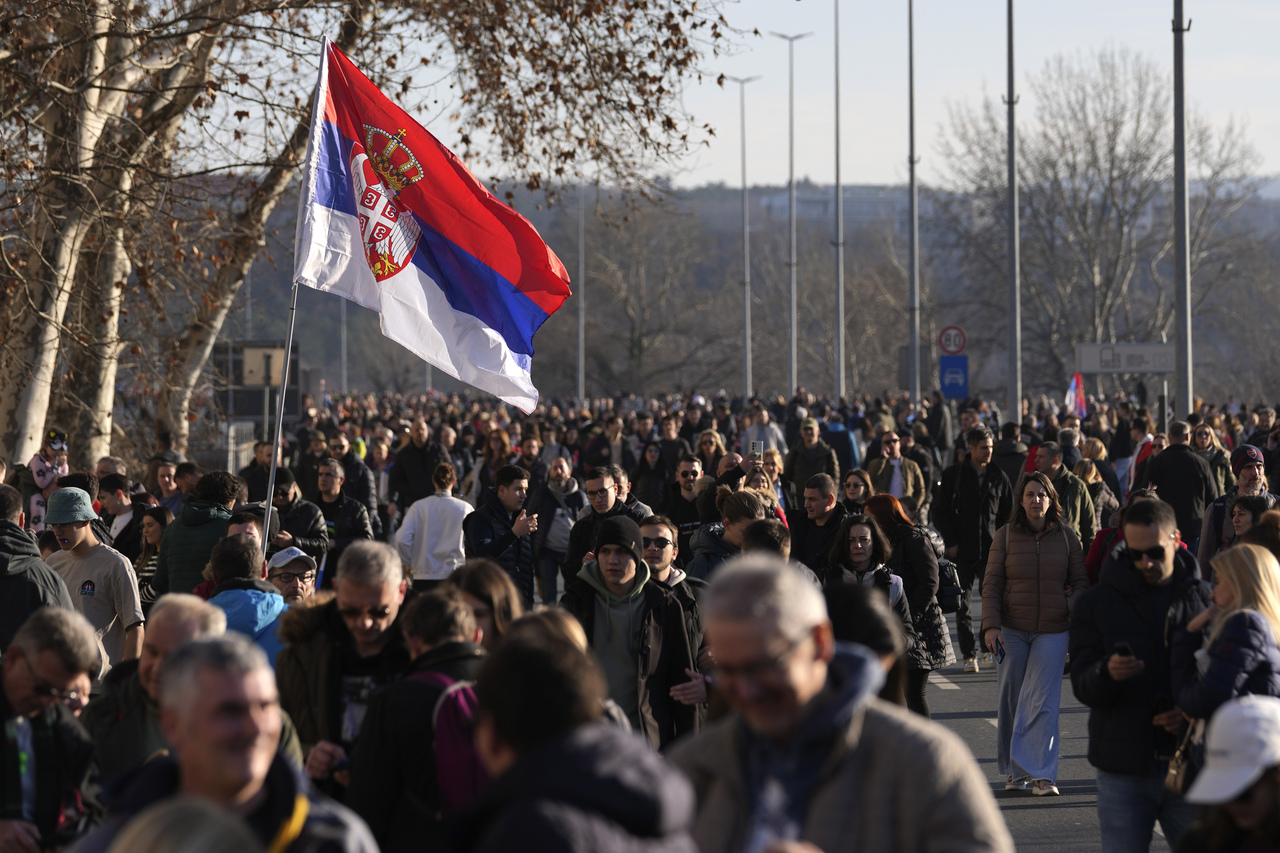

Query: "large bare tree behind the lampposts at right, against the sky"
left=933, top=49, right=1258, bottom=399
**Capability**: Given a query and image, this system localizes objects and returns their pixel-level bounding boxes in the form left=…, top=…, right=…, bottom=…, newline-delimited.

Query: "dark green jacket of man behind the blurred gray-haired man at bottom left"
left=79, top=660, right=302, bottom=779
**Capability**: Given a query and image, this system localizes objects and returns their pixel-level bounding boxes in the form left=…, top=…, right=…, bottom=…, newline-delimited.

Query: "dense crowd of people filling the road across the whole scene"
left=0, top=389, right=1280, bottom=853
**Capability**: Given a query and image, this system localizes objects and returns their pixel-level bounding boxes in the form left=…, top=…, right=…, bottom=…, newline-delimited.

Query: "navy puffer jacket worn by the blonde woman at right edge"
left=1172, top=610, right=1280, bottom=720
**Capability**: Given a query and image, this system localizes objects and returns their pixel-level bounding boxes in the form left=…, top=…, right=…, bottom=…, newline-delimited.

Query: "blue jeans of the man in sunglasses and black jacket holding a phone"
left=1098, top=761, right=1196, bottom=853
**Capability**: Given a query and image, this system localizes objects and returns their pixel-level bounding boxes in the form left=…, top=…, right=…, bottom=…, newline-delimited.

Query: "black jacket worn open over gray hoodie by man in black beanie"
left=561, top=562, right=698, bottom=749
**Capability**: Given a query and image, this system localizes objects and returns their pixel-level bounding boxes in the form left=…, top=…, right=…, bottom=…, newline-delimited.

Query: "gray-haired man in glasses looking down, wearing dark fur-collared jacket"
left=275, top=540, right=410, bottom=794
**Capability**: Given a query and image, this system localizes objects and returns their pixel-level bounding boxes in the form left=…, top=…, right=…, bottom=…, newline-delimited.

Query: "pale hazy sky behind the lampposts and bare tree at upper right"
left=673, top=0, right=1280, bottom=186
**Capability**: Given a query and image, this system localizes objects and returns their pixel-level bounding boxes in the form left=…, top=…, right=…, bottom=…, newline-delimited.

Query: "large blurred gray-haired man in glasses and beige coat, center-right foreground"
left=669, top=553, right=1014, bottom=853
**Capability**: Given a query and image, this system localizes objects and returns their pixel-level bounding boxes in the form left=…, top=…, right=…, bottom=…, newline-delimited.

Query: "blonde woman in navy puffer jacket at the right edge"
left=1170, top=544, right=1280, bottom=720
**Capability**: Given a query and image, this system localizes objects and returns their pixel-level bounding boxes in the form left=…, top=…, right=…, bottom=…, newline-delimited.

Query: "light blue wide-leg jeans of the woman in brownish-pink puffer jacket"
left=996, top=628, right=1068, bottom=781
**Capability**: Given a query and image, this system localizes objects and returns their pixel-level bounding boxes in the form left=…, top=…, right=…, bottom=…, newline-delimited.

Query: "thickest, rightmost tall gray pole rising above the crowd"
left=1174, top=0, right=1196, bottom=414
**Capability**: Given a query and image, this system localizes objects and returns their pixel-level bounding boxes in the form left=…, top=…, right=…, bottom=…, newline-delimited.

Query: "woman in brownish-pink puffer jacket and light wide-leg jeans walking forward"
left=982, top=471, right=1089, bottom=797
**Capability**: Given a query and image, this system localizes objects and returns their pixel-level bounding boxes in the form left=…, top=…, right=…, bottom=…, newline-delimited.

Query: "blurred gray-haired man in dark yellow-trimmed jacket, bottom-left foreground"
left=76, top=634, right=378, bottom=853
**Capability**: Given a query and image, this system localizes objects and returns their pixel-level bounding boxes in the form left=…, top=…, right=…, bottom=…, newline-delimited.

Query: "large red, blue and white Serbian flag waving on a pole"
left=293, top=41, right=570, bottom=412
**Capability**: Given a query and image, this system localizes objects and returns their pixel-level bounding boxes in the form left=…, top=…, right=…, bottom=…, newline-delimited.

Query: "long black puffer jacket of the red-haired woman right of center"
left=887, top=524, right=956, bottom=670
